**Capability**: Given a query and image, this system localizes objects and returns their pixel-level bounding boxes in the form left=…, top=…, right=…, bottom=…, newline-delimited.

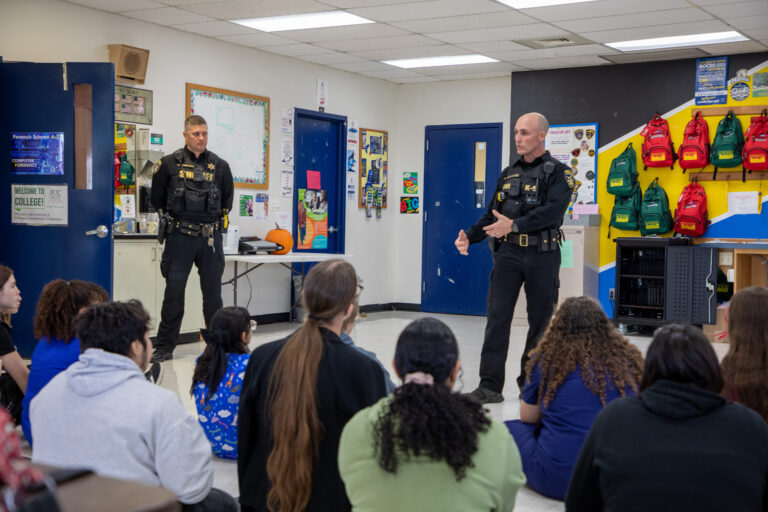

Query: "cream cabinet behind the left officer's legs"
left=112, top=238, right=205, bottom=336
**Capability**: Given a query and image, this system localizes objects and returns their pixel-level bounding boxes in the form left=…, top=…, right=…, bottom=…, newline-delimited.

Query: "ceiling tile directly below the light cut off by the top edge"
left=521, top=0, right=690, bottom=21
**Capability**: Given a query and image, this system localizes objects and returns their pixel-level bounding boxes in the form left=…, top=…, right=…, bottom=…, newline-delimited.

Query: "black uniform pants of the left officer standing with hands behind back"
left=155, top=231, right=224, bottom=353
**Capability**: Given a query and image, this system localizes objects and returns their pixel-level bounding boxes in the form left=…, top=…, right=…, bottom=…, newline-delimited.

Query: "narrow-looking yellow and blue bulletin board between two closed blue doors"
left=358, top=128, right=389, bottom=208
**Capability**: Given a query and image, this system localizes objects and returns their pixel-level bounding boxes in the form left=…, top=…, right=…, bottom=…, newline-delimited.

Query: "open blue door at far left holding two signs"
left=0, top=62, right=115, bottom=356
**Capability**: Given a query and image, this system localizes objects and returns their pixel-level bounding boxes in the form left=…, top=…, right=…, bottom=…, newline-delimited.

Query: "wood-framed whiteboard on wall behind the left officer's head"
left=186, top=83, right=269, bottom=189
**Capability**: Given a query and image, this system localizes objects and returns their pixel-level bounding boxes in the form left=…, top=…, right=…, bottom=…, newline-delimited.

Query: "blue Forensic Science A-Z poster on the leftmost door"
left=11, top=132, right=64, bottom=176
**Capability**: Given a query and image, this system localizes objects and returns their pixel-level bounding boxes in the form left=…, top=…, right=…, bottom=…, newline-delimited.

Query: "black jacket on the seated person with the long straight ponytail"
left=237, top=328, right=386, bottom=512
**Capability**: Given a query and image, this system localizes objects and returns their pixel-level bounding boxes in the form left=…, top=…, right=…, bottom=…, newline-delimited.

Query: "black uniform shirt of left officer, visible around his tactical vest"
left=149, top=147, right=235, bottom=222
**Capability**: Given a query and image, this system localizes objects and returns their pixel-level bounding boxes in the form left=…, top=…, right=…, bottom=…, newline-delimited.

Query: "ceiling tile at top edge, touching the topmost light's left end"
left=350, top=0, right=509, bottom=22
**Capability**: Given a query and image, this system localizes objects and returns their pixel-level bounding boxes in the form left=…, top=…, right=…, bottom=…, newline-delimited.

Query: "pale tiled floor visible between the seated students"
left=160, top=312, right=727, bottom=512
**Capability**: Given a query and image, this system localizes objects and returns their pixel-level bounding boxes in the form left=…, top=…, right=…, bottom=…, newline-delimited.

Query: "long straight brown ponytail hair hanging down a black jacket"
left=267, top=259, right=357, bottom=512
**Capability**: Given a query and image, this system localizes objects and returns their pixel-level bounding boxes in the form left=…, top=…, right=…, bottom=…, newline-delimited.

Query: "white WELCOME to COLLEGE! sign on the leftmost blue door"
left=11, top=184, right=69, bottom=226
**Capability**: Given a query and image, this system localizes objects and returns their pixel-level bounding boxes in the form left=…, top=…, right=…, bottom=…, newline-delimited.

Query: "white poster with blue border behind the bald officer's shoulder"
left=544, top=123, right=597, bottom=204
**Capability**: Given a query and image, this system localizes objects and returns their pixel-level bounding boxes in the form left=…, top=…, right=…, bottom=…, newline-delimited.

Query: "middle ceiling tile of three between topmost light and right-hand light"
left=552, top=7, right=713, bottom=33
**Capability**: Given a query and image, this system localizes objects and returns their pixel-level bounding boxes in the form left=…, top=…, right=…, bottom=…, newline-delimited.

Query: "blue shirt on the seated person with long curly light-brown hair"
left=523, top=365, right=637, bottom=468
